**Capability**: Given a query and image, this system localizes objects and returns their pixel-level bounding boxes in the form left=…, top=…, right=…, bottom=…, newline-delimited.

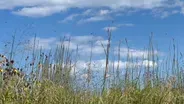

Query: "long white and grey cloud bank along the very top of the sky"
left=0, top=0, right=184, bottom=18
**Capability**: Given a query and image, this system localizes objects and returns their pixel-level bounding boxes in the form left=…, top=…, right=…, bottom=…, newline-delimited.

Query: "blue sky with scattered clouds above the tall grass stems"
left=0, top=0, right=184, bottom=77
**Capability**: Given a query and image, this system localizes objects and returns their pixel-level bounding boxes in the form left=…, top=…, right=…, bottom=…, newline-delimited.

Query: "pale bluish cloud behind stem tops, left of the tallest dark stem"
left=30, top=35, right=107, bottom=56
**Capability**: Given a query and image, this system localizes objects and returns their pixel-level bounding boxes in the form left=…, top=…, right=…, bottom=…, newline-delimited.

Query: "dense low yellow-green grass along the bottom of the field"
left=0, top=81, right=184, bottom=104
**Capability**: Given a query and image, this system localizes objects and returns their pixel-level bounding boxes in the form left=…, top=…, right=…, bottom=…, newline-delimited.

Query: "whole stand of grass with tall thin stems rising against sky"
left=0, top=30, right=184, bottom=104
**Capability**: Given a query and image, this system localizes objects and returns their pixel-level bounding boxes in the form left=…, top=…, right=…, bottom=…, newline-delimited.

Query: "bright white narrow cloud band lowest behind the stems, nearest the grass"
left=71, top=59, right=159, bottom=72
